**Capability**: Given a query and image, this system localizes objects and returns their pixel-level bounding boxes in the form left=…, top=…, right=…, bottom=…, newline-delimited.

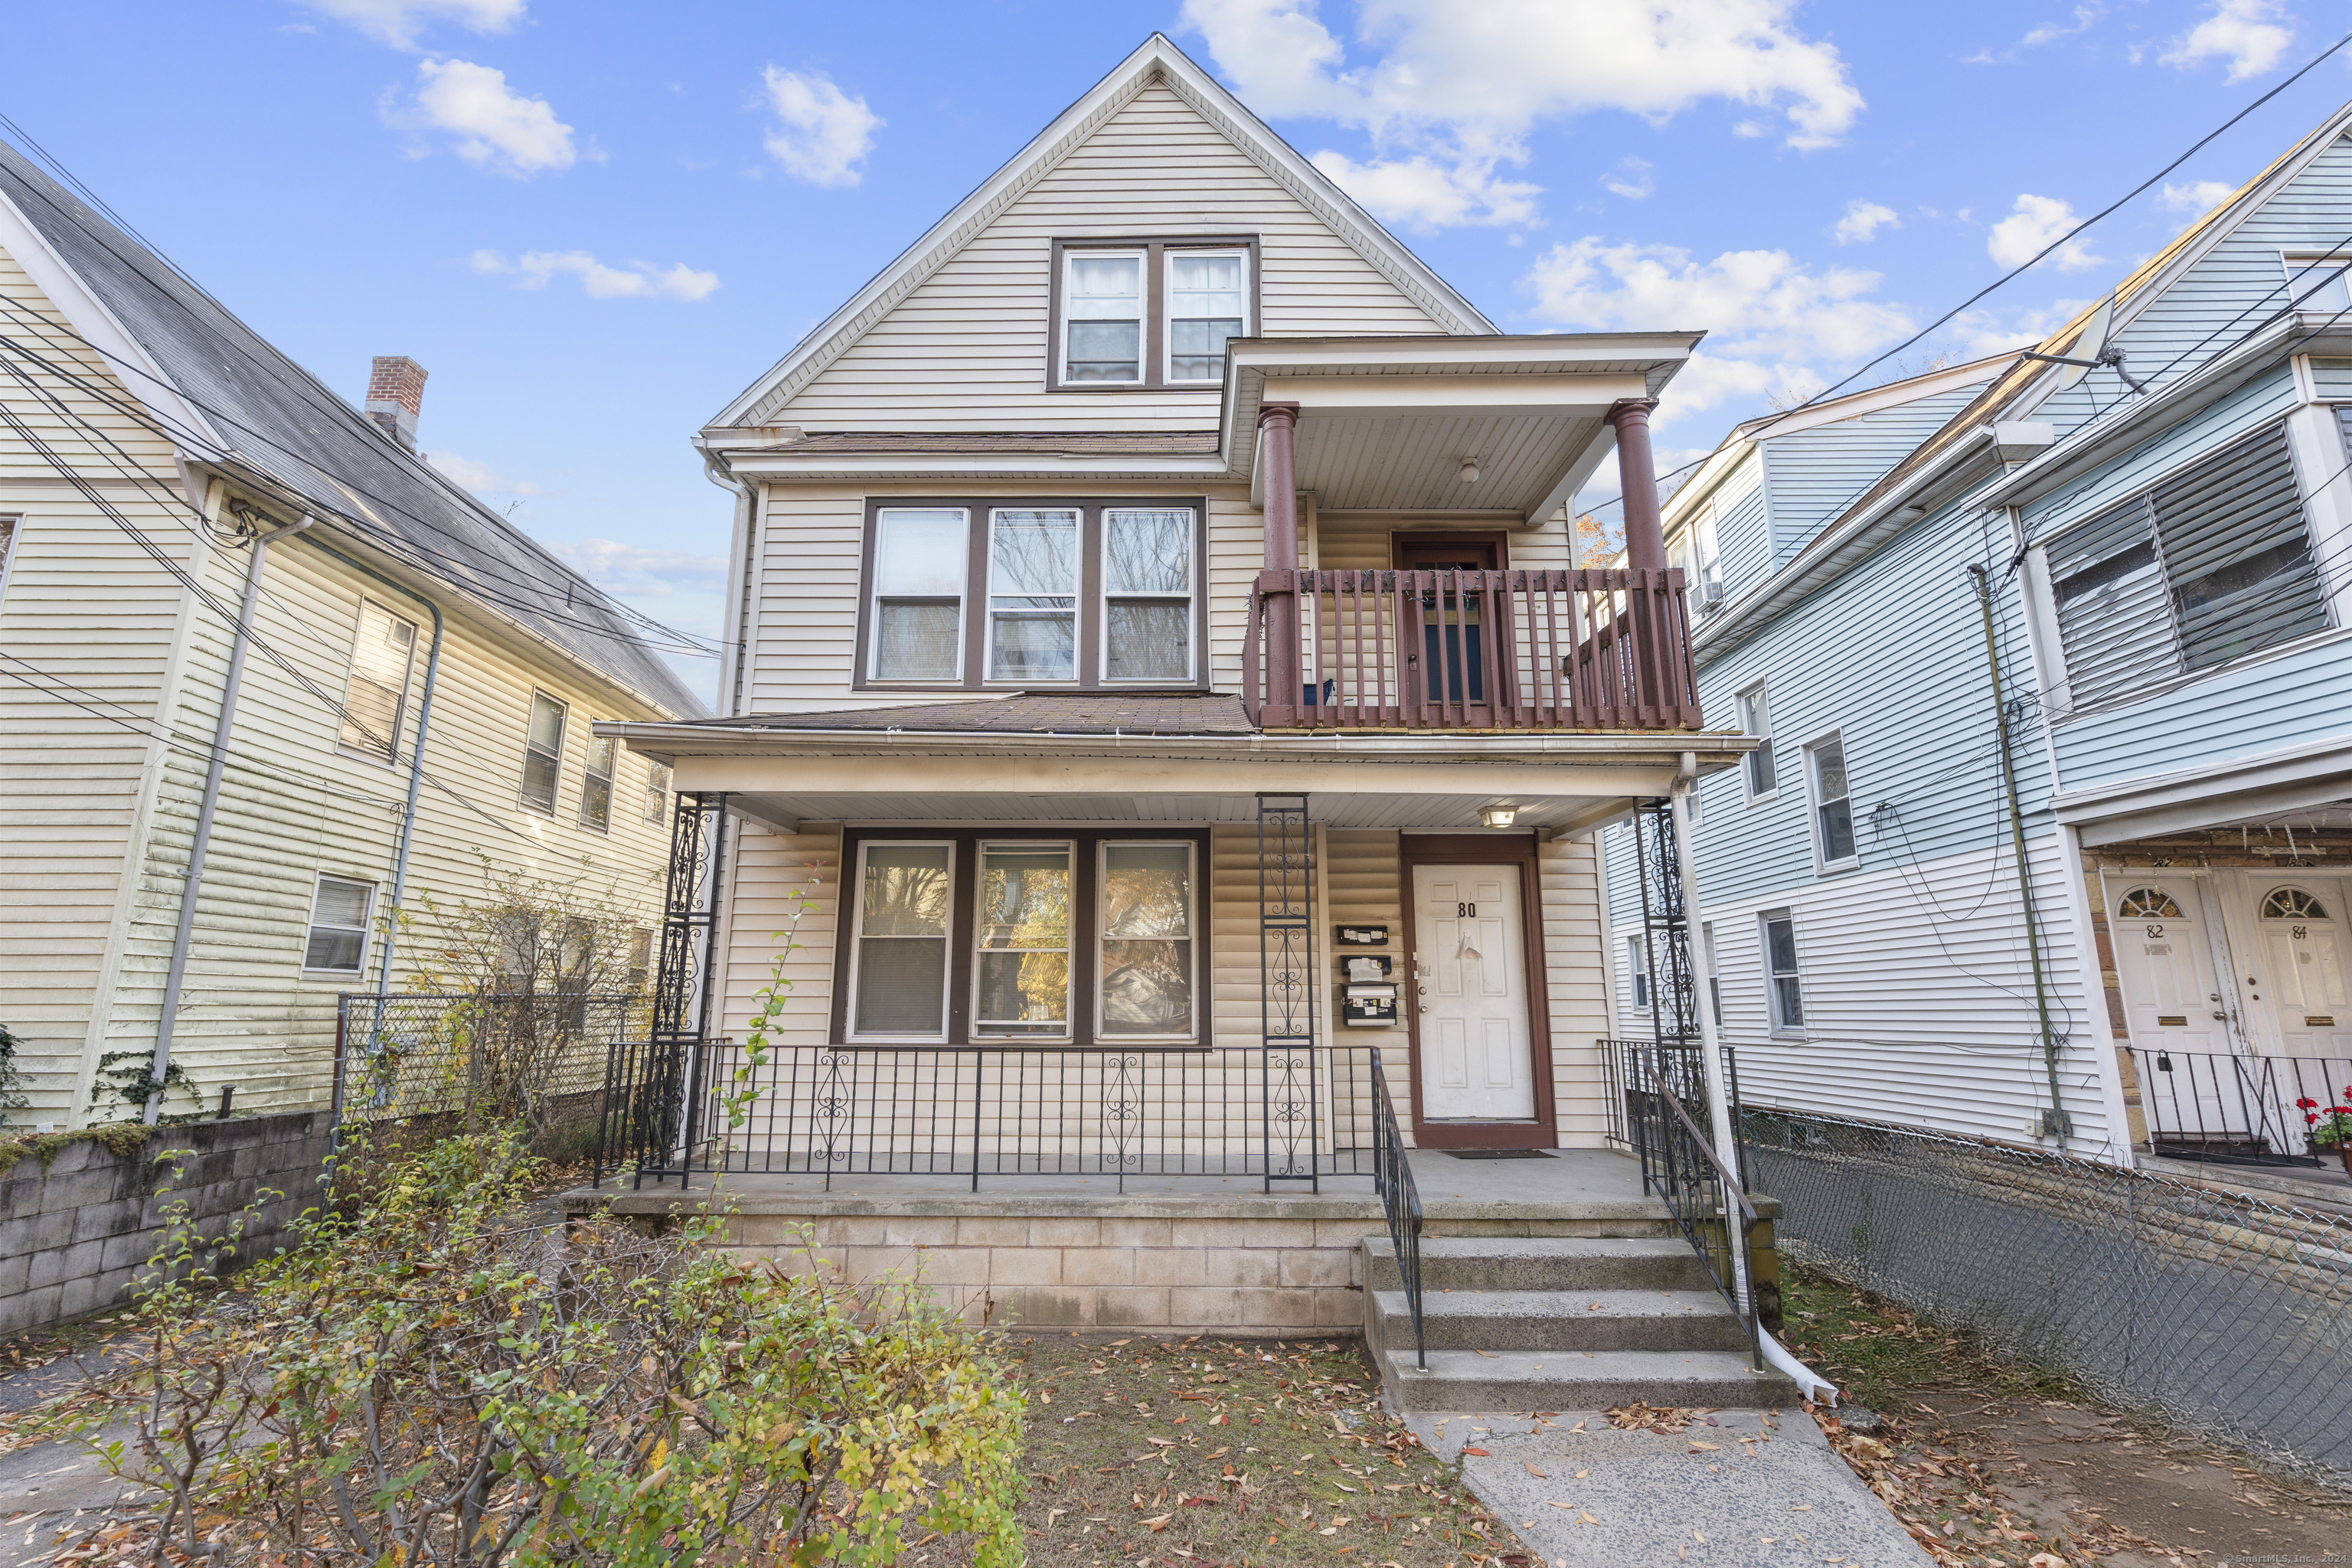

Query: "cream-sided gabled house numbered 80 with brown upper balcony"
left=597, top=35, right=1753, bottom=1180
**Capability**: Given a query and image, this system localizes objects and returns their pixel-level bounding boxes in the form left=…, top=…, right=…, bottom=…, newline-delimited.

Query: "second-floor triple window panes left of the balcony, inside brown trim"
left=858, top=498, right=1204, bottom=691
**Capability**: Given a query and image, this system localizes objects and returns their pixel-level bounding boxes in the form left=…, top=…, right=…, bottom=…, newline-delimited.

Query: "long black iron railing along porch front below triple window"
left=595, top=1041, right=1376, bottom=1192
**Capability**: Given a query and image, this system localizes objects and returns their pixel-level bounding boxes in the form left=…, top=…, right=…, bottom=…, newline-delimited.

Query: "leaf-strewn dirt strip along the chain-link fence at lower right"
left=1785, top=1269, right=2352, bottom=1568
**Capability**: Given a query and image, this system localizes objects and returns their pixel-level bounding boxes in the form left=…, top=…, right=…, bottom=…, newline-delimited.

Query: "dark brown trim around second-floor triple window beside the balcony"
left=849, top=496, right=1209, bottom=694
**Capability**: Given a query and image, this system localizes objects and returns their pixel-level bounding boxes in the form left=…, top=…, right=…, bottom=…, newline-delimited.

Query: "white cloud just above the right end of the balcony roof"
left=1527, top=235, right=1913, bottom=426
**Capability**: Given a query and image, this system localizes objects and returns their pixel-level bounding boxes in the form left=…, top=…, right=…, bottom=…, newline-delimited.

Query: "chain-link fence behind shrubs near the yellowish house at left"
left=334, top=992, right=652, bottom=1159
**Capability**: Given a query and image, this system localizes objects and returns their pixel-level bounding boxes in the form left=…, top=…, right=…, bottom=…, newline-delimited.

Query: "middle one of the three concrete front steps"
left=1371, top=1291, right=1747, bottom=1352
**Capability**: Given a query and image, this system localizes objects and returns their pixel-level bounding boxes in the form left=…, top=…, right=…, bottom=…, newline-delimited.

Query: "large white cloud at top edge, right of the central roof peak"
left=1183, top=0, right=1863, bottom=228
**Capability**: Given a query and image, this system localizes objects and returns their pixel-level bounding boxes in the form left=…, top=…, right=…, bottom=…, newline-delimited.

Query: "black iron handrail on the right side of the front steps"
left=1599, top=1039, right=1764, bottom=1366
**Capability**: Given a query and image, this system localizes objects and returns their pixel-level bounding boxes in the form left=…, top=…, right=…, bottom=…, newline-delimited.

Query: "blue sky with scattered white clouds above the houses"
left=0, top=0, right=2352, bottom=700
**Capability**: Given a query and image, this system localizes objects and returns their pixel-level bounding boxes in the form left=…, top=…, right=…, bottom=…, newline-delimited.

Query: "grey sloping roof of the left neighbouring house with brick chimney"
left=0, top=141, right=708, bottom=717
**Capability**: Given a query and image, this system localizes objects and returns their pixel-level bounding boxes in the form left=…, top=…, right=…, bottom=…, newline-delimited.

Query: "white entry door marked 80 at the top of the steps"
left=1411, top=865, right=1536, bottom=1122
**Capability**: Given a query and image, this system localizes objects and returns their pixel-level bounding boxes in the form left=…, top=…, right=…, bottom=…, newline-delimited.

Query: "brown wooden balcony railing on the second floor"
left=1242, top=567, right=1700, bottom=729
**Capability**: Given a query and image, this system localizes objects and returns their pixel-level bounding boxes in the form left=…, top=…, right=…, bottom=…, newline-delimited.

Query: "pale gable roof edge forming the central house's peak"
left=710, top=33, right=1496, bottom=430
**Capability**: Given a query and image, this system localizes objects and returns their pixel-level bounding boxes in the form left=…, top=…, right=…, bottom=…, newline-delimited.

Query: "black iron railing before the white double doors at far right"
left=2124, top=1046, right=2352, bottom=1166
